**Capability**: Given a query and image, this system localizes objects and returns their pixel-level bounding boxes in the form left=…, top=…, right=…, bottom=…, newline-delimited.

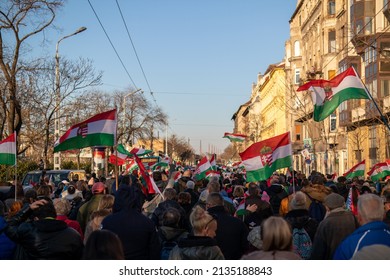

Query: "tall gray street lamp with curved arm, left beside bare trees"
left=54, top=27, right=87, bottom=169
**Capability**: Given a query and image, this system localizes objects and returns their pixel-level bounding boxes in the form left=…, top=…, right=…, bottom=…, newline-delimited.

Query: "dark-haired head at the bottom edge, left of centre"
left=83, top=229, right=125, bottom=260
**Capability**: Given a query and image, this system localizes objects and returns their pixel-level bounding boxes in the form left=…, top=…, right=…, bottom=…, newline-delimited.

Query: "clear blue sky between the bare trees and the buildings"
left=45, top=0, right=296, bottom=152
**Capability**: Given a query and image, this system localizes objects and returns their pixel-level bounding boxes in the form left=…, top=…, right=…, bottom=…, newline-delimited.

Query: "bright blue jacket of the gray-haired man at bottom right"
left=333, top=221, right=390, bottom=260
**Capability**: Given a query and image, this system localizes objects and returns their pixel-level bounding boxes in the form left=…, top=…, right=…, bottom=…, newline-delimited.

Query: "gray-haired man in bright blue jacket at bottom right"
left=333, top=194, right=390, bottom=260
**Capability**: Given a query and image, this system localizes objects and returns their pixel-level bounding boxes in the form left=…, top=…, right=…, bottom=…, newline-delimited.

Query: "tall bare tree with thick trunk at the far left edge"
left=0, top=0, right=63, bottom=141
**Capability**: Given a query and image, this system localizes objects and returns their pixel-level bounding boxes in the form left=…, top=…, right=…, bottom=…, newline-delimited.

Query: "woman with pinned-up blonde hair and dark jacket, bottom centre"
left=169, top=205, right=225, bottom=260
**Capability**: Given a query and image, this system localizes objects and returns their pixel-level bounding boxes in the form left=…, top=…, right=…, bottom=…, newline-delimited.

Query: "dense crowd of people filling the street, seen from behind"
left=0, top=168, right=390, bottom=260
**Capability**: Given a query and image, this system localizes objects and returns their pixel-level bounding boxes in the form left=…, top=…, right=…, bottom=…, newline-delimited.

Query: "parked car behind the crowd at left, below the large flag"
left=22, top=169, right=86, bottom=189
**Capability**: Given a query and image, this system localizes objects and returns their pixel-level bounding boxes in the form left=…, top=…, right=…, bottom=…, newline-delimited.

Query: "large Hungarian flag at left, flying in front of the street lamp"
left=54, top=109, right=117, bottom=153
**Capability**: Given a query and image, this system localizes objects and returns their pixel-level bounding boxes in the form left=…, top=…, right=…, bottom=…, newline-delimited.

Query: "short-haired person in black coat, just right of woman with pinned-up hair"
left=206, top=192, right=248, bottom=260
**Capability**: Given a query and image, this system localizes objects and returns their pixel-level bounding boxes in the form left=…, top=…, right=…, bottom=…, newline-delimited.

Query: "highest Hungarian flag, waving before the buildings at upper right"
left=298, top=67, right=370, bottom=122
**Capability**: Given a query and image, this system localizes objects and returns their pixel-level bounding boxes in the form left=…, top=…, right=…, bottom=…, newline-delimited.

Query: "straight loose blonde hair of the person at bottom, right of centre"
left=261, top=216, right=292, bottom=251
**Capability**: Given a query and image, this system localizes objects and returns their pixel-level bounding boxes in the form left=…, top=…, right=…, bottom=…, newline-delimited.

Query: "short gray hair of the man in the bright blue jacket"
left=357, top=193, right=385, bottom=224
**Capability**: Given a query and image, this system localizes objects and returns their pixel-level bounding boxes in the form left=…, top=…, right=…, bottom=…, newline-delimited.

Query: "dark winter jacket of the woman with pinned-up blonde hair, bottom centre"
left=169, top=235, right=225, bottom=260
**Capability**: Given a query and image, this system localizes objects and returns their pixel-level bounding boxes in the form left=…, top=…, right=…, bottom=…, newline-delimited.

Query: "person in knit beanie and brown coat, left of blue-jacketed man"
left=310, top=193, right=358, bottom=260
